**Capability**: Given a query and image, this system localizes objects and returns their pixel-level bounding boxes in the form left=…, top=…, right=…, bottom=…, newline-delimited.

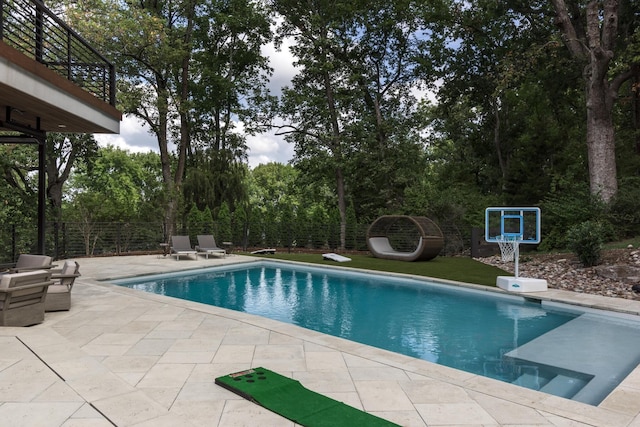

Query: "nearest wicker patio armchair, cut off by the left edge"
left=0, top=270, right=52, bottom=326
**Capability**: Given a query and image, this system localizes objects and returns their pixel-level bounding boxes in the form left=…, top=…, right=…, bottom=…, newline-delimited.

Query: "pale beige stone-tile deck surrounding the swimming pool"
left=0, top=255, right=640, bottom=427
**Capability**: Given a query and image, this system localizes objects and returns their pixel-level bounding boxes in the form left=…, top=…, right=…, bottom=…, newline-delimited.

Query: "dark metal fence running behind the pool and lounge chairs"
left=0, top=222, right=470, bottom=263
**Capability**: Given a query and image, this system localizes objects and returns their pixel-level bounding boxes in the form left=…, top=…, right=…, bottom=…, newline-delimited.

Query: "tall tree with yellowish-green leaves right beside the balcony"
left=66, top=0, right=195, bottom=235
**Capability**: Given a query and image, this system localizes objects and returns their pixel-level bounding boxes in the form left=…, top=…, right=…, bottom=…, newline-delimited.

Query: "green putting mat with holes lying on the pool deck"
left=216, top=368, right=399, bottom=427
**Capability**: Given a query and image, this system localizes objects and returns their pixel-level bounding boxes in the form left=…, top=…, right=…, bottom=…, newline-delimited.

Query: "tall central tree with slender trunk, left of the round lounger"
left=273, top=0, right=428, bottom=248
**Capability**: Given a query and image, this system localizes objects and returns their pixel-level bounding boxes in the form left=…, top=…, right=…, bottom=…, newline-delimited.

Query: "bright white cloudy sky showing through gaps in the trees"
left=94, top=35, right=296, bottom=168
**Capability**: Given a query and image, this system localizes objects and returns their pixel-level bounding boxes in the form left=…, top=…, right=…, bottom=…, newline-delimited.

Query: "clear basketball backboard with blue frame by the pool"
left=484, top=207, right=541, bottom=244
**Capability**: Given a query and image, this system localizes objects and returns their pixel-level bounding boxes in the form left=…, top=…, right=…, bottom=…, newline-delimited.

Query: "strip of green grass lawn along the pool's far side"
left=245, top=252, right=512, bottom=286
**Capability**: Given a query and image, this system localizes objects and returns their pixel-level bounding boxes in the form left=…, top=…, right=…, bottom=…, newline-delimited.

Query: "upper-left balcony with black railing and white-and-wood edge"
left=0, top=0, right=122, bottom=136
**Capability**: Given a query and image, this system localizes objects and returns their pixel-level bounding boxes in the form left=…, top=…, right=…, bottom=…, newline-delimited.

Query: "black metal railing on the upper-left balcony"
left=0, top=0, right=116, bottom=106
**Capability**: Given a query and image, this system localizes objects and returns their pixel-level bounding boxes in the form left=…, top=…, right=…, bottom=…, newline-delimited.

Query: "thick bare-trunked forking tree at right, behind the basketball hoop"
left=551, top=0, right=640, bottom=203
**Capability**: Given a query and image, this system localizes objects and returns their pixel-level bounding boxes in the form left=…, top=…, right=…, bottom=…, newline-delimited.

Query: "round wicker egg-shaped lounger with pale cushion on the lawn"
left=367, top=215, right=444, bottom=261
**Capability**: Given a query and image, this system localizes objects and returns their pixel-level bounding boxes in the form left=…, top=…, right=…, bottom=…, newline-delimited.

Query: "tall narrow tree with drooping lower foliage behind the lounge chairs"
left=184, top=0, right=272, bottom=217
